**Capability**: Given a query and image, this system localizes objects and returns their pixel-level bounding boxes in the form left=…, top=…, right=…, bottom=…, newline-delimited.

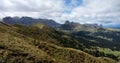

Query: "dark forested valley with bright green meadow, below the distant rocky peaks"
left=66, top=28, right=120, bottom=60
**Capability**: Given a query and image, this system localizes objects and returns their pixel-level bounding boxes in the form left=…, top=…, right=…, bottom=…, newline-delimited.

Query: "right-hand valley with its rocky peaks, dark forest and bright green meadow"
left=58, top=22, right=120, bottom=60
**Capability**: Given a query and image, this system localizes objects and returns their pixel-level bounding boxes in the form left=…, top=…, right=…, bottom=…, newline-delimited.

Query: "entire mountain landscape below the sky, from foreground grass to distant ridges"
left=0, top=17, right=120, bottom=63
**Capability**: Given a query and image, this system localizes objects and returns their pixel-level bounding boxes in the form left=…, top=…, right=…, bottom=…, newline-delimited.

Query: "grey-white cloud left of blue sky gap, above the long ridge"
left=0, top=0, right=64, bottom=22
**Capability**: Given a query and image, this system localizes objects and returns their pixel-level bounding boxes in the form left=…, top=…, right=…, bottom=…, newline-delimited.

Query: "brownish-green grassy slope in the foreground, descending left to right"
left=0, top=23, right=115, bottom=63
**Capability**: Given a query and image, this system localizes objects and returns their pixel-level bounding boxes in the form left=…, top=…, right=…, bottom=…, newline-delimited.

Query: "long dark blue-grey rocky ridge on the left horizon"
left=3, top=17, right=60, bottom=27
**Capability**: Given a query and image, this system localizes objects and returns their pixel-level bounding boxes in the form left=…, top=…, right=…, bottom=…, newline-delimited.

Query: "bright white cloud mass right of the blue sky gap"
left=63, top=0, right=120, bottom=24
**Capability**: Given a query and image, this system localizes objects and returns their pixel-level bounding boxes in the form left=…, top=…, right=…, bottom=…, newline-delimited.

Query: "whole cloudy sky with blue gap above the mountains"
left=0, top=0, right=120, bottom=25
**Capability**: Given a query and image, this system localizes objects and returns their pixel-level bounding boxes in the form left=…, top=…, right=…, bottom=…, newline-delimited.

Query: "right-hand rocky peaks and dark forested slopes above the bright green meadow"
left=58, top=21, right=120, bottom=51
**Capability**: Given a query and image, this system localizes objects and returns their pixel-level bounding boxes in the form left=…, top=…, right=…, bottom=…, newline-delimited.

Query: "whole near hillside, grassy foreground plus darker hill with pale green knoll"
left=0, top=22, right=116, bottom=63
